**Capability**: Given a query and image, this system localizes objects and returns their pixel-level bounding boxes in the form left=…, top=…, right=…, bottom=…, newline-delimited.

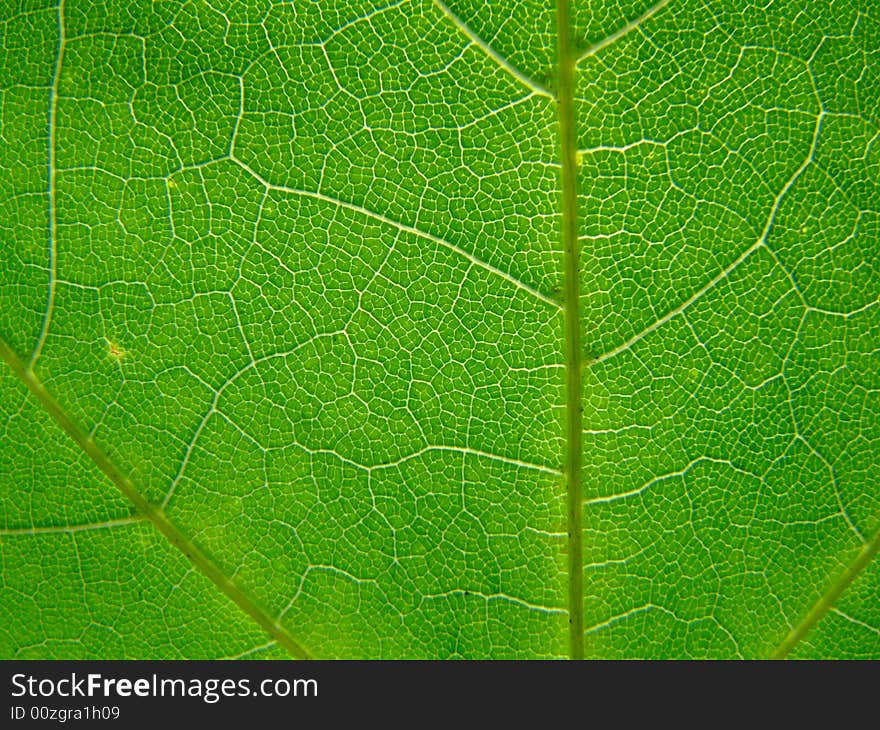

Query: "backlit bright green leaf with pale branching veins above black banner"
left=0, top=0, right=880, bottom=658
